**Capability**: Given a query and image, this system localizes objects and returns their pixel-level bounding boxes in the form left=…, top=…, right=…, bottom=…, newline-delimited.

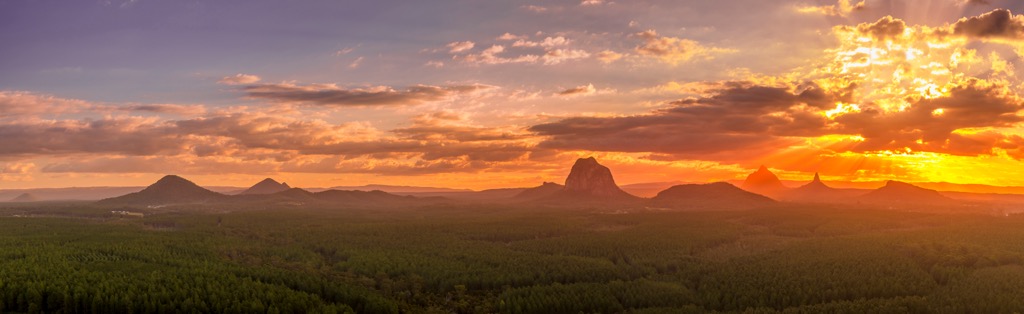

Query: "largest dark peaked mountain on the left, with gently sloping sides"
left=97, top=175, right=227, bottom=206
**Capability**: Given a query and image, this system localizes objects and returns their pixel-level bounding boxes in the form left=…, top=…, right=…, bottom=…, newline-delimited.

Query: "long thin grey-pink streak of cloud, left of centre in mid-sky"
left=242, top=83, right=495, bottom=106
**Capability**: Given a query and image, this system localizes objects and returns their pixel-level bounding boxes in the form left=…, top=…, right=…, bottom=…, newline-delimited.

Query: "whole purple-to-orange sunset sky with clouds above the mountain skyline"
left=0, top=0, right=1024, bottom=189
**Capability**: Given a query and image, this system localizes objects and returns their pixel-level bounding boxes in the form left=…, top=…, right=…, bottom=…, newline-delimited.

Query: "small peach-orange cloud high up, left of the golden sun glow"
left=635, top=30, right=731, bottom=65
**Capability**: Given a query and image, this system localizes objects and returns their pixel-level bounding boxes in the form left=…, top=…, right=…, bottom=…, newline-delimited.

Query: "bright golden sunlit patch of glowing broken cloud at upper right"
left=816, top=19, right=974, bottom=114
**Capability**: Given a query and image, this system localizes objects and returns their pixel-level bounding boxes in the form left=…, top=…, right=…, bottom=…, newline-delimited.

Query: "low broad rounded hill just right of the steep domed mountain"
left=650, top=182, right=776, bottom=211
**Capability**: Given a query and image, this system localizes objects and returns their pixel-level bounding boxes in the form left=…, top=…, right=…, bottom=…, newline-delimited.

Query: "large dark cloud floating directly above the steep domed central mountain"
left=529, top=83, right=834, bottom=155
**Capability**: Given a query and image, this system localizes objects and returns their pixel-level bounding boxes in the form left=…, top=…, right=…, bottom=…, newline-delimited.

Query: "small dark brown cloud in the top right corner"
left=952, top=9, right=1024, bottom=40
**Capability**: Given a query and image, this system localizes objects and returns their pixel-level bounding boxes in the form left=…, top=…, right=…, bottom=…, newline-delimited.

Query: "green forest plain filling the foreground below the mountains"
left=0, top=203, right=1024, bottom=313
